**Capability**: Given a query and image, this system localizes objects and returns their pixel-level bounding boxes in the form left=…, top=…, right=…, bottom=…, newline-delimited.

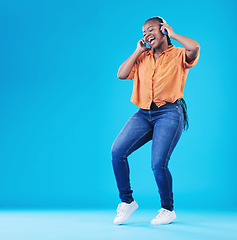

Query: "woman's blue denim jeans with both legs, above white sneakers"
left=111, top=100, right=184, bottom=210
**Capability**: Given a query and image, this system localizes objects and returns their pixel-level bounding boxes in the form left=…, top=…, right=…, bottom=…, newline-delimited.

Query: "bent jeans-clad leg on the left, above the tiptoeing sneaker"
left=111, top=111, right=153, bottom=203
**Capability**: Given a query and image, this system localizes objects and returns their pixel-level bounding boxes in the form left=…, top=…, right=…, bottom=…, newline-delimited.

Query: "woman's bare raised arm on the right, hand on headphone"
left=161, top=23, right=200, bottom=63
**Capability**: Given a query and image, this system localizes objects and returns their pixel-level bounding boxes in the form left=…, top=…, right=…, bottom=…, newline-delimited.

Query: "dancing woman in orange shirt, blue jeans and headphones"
left=111, top=17, right=200, bottom=225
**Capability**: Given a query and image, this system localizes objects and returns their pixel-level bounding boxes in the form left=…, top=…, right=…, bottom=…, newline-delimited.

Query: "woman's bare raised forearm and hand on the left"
left=117, top=38, right=151, bottom=79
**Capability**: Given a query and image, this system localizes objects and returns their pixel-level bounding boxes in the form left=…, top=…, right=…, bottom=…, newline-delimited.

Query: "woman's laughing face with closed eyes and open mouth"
left=142, top=20, right=165, bottom=48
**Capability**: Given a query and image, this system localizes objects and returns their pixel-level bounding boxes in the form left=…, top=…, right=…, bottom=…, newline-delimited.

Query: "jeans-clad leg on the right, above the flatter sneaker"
left=151, top=104, right=183, bottom=211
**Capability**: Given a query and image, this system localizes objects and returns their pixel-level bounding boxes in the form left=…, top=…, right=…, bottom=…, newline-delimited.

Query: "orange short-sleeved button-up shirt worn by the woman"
left=125, top=45, right=199, bottom=109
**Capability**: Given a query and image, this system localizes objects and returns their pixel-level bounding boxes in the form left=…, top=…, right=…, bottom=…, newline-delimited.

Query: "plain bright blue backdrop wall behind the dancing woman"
left=0, top=0, right=237, bottom=209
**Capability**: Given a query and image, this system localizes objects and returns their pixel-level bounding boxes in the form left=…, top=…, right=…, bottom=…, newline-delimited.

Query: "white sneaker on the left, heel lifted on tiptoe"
left=114, top=200, right=138, bottom=224
